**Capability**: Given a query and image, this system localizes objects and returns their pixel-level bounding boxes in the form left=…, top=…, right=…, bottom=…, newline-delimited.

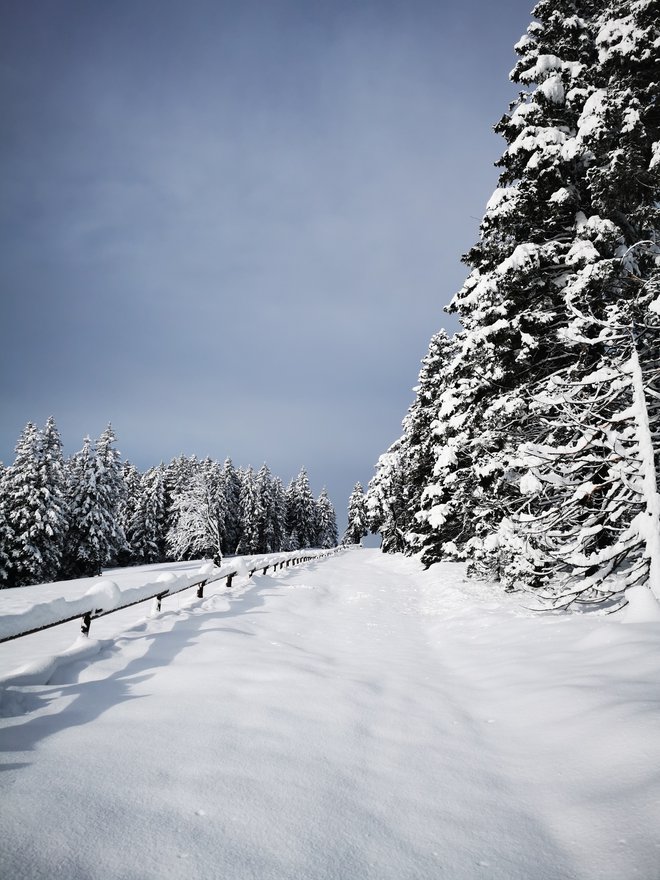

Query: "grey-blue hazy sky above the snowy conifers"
left=0, top=0, right=532, bottom=516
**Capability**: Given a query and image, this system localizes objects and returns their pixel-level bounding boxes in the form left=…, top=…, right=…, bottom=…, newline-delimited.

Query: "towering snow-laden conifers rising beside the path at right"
left=367, top=0, right=660, bottom=607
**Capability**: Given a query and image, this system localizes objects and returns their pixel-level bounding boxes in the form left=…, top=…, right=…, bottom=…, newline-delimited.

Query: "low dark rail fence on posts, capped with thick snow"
left=0, top=547, right=340, bottom=644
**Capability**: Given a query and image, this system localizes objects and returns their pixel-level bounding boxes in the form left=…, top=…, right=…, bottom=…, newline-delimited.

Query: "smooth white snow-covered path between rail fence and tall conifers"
left=0, top=549, right=660, bottom=880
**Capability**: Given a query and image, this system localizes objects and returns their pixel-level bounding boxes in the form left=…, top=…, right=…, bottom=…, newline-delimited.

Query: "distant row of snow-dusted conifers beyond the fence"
left=0, top=418, right=337, bottom=587
